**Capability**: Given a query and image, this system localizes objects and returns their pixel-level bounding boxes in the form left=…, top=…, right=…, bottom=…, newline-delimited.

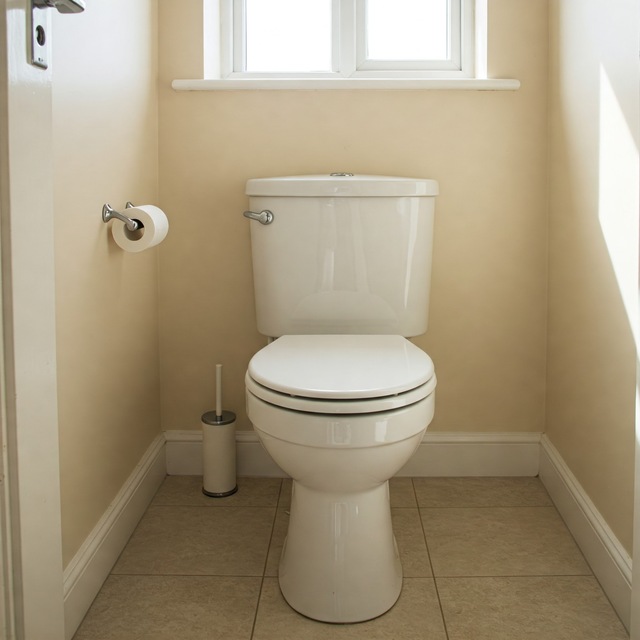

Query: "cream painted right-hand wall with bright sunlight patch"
left=547, top=0, right=640, bottom=552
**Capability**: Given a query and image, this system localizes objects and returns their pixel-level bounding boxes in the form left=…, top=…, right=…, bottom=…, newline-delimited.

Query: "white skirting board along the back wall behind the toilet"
left=165, top=430, right=541, bottom=477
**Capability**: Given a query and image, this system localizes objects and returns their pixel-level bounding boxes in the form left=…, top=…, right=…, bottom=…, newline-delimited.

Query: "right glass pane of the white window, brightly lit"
left=366, top=0, right=449, bottom=60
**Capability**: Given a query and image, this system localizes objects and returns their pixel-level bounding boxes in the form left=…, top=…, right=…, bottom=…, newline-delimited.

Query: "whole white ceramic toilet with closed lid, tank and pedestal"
left=245, top=174, right=438, bottom=623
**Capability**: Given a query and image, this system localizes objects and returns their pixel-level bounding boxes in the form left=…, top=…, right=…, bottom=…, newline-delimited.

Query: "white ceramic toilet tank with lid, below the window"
left=246, top=174, right=438, bottom=337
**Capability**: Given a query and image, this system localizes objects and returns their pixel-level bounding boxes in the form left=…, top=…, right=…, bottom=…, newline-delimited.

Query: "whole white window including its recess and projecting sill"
left=171, top=0, right=520, bottom=91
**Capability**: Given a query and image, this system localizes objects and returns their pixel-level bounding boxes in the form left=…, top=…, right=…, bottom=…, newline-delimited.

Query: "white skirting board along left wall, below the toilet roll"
left=64, top=434, right=167, bottom=640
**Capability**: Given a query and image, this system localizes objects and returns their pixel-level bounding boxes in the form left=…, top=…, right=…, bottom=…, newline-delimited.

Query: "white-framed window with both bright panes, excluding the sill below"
left=220, top=0, right=475, bottom=79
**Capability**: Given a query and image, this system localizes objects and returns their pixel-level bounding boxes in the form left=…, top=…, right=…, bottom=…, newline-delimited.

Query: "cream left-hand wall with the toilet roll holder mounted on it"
left=53, top=0, right=160, bottom=564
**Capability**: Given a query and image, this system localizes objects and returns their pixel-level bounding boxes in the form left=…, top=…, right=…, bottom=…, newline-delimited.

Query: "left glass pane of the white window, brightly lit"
left=246, top=0, right=332, bottom=72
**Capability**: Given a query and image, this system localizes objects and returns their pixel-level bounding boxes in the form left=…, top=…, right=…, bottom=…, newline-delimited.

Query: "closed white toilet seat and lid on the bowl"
left=245, top=335, right=436, bottom=414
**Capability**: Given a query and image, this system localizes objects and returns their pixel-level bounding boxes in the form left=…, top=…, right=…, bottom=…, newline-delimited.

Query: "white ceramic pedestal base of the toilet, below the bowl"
left=279, top=480, right=402, bottom=623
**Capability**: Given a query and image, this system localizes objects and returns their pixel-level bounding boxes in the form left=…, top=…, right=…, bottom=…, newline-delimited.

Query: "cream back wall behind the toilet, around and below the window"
left=159, top=0, right=547, bottom=431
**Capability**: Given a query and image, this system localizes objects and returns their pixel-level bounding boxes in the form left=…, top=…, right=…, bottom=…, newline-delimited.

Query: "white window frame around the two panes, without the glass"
left=218, top=0, right=476, bottom=80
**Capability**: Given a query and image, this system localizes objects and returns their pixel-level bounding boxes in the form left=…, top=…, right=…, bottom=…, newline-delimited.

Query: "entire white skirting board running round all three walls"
left=64, top=430, right=631, bottom=640
